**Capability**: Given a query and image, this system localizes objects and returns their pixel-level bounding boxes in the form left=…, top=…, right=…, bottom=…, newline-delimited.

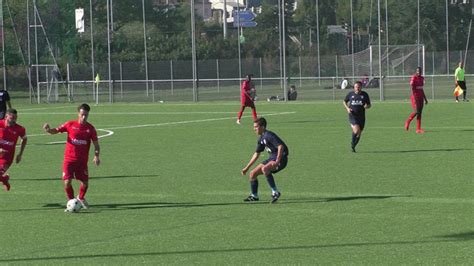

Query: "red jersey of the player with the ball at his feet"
left=56, top=121, right=98, bottom=163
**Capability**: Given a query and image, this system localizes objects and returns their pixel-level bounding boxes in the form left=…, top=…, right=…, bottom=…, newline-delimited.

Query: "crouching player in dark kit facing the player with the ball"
left=242, top=117, right=289, bottom=203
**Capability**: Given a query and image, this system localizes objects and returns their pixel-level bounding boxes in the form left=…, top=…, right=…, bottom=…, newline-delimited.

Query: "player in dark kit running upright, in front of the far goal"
left=343, top=81, right=371, bottom=152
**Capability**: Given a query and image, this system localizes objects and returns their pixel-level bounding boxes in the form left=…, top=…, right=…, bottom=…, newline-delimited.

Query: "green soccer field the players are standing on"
left=0, top=101, right=474, bottom=265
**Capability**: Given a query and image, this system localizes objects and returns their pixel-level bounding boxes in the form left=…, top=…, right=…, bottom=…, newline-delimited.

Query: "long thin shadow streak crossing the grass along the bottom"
left=0, top=231, right=474, bottom=263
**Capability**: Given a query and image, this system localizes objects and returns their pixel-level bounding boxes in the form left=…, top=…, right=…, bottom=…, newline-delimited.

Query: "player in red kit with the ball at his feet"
left=43, top=103, right=100, bottom=209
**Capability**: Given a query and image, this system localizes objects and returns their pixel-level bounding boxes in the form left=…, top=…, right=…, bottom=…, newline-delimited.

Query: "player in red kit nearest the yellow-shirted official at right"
left=405, top=67, right=428, bottom=134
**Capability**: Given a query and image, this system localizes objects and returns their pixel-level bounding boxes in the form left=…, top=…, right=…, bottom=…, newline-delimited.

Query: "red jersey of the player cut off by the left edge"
left=0, top=119, right=26, bottom=164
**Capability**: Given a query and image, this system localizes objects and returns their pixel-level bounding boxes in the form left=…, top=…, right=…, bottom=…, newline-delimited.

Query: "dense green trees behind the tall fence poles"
left=4, top=0, right=471, bottom=65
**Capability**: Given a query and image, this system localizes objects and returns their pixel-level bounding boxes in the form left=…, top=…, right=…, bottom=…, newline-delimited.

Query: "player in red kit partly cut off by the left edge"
left=0, top=109, right=28, bottom=191
